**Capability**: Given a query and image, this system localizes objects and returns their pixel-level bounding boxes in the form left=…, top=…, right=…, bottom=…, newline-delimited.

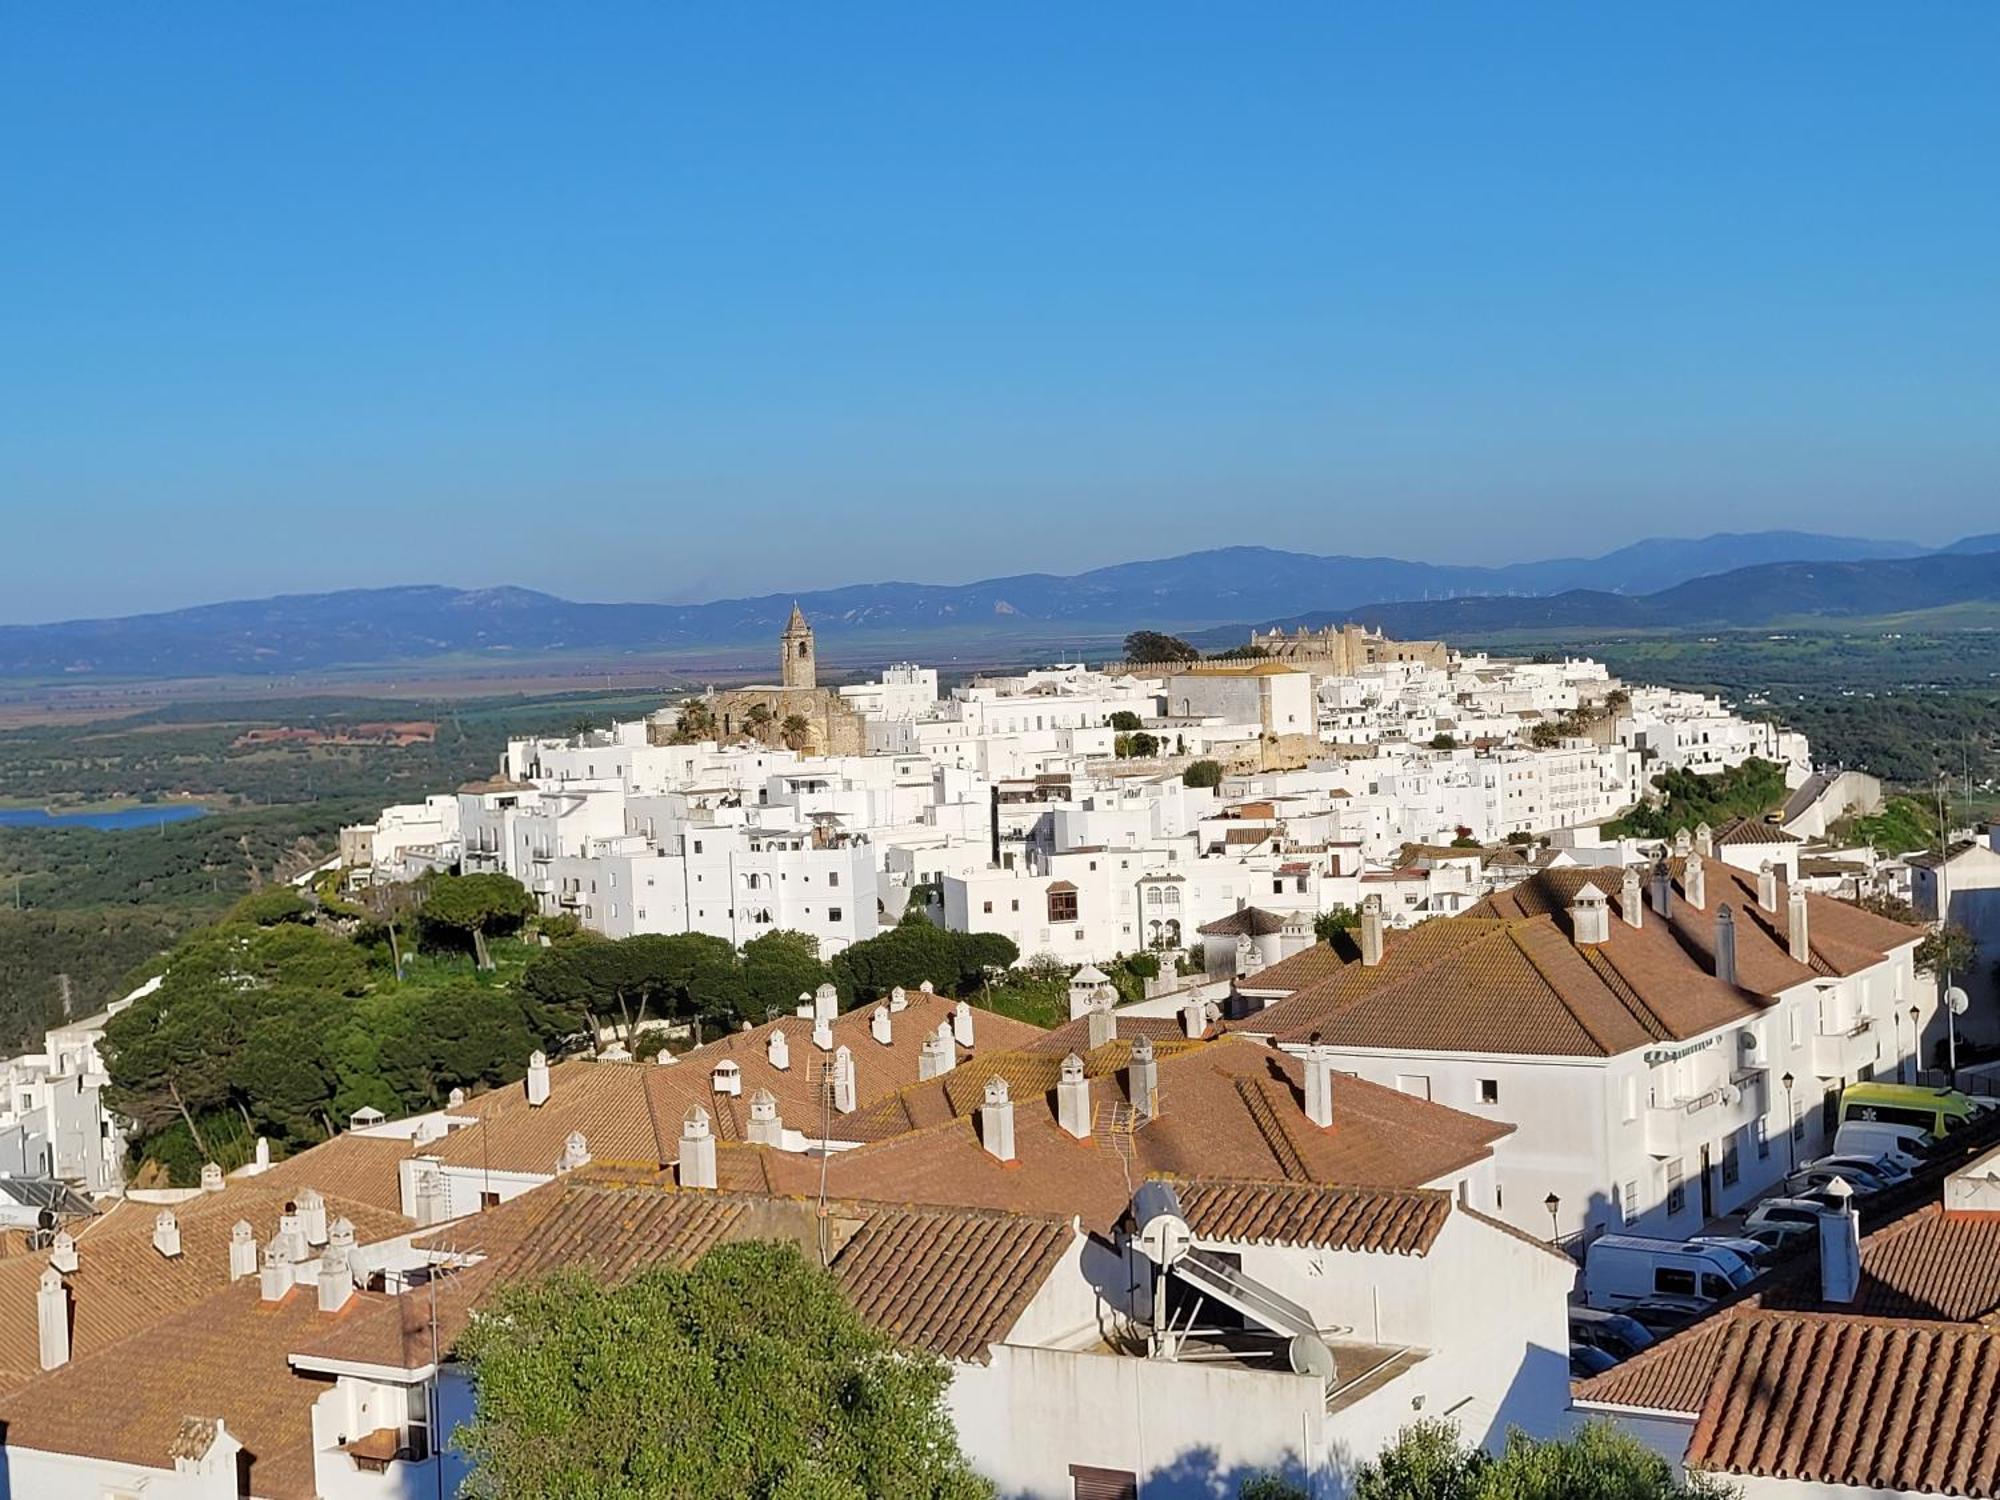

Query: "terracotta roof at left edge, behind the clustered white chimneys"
left=0, top=1178, right=410, bottom=1390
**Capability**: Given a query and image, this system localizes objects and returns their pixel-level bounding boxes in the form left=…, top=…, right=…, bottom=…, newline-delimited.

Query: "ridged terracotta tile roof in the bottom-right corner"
left=1686, top=1312, right=2000, bottom=1496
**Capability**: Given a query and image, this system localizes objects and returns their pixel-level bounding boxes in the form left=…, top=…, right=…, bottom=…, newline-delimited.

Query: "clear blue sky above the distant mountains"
left=0, top=0, right=2000, bottom=620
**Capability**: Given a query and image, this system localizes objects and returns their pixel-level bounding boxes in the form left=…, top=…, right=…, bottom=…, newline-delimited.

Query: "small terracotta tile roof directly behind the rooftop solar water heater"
left=1176, top=1180, right=1452, bottom=1256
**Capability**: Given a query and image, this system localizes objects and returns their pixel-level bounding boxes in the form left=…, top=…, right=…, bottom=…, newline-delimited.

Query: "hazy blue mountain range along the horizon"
left=0, top=532, right=2000, bottom=680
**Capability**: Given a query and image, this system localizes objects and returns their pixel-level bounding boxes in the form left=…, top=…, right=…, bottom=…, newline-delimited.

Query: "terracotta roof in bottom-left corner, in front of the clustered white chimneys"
left=0, top=1278, right=372, bottom=1500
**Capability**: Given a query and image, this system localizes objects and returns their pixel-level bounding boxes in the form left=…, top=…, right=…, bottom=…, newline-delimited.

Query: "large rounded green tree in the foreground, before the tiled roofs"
left=458, top=1242, right=992, bottom=1500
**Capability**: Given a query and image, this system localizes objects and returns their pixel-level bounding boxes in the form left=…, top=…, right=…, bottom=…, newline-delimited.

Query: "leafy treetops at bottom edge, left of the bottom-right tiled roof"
left=1354, top=1420, right=1734, bottom=1500
